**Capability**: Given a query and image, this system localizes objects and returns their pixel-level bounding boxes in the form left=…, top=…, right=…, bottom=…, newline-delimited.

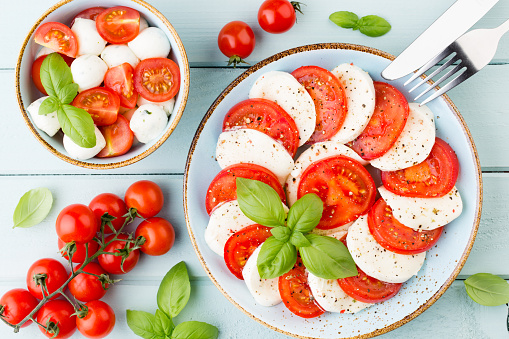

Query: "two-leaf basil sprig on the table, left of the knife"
left=329, top=11, right=391, bottom=37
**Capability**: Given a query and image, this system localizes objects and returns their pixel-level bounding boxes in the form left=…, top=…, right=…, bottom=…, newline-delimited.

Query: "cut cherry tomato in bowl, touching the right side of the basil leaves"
left=71, top=87, right=120, bottom=126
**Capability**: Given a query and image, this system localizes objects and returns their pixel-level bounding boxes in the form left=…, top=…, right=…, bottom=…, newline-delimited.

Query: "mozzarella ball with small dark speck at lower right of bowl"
left=129, top=104, right=168, bottom=144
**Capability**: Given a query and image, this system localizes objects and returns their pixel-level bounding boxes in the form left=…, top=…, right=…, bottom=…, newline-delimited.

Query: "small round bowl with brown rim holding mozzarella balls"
left=16, top=0, right=190, bottom=169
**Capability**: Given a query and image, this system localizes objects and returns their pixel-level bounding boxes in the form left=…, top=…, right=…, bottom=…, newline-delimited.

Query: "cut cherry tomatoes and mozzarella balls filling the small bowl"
left=27, top=6, right=180, bottom=160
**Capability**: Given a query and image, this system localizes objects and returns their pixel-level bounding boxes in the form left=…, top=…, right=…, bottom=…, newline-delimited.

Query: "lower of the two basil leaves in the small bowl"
left=58, top=104, right=96, bottom=148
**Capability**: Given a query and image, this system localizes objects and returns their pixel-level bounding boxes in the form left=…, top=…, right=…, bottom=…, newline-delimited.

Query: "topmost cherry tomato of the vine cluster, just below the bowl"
left=124, top=180, right=164, bottom=218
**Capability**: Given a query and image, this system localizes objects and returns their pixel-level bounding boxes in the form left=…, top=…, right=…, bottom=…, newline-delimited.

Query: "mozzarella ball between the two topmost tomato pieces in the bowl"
left=71, top=18, right=106, bottom=55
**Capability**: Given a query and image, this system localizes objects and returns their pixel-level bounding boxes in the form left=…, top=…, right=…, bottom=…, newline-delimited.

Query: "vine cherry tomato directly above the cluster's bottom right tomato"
left=67, top=262, right=109, bottom=302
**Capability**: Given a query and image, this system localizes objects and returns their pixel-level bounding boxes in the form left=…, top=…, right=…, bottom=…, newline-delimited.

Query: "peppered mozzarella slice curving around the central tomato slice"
left=285, top=141, right=369, bottom=206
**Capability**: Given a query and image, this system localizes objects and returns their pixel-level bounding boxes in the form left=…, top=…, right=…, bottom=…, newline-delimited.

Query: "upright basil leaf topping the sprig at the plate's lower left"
left=157, top=261, right=191, bottom=318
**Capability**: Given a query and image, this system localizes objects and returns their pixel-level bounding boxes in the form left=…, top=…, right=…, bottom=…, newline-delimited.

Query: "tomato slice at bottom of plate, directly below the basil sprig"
left=278, top=258, right=325, bottom=318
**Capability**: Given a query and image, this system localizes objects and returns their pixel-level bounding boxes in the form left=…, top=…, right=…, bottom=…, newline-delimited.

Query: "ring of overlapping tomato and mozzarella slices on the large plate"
left=201, top=63, right=462, bottom=318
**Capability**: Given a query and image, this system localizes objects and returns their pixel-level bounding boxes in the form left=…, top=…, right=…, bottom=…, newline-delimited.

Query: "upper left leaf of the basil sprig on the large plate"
left=236, top=177, right=286, bottom=227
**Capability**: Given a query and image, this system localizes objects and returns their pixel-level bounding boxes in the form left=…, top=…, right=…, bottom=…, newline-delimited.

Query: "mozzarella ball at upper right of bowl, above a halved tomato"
left=127, top=27, right=171, bottom=60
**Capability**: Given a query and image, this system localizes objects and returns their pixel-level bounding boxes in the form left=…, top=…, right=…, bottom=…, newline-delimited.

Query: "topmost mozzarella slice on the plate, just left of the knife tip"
left=331, top=64, right=375, bottom=144
